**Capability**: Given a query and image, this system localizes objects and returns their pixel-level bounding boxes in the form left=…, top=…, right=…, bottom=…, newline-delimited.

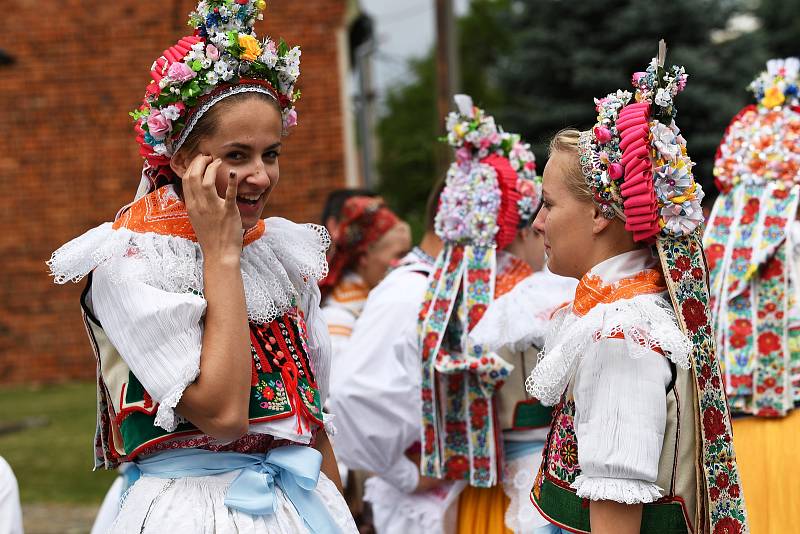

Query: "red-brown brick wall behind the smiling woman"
left=0, top=0, right=345, bottom=384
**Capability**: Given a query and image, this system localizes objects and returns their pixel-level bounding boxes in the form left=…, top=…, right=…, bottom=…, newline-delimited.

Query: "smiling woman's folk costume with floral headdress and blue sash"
left=48, top=0, right=355, bottom=533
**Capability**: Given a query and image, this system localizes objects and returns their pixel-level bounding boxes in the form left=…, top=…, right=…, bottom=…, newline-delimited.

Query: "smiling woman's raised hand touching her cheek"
left=182, top=154, right=242, bottom=264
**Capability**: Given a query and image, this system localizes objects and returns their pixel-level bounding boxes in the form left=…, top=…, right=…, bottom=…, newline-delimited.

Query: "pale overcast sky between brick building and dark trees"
left=361, top=0, right=469, bottom=98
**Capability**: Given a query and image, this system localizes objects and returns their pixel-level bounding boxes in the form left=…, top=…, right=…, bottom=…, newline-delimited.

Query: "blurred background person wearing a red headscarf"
left=319, top=196, right=411, bottom=361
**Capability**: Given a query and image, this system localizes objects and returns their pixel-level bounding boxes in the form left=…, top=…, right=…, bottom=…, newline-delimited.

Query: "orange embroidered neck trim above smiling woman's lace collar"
left=113, top=186, right=265, bottom=246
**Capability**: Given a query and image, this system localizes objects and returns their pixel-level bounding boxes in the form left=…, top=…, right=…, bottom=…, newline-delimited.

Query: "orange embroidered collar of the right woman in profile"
left=572, top=250, right=667, bottom=317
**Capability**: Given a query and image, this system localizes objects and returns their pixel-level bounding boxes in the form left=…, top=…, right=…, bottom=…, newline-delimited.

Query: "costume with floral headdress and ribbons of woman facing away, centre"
left=418, top=95, right=571, bottom=532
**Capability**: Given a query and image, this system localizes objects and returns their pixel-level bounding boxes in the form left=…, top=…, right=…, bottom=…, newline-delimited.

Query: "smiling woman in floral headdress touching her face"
left=49, top=0, right=355, bottom=533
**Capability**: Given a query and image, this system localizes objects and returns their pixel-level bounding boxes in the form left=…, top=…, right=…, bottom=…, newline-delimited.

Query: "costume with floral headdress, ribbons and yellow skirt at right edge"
left=703, top=58, right=800, bottom=533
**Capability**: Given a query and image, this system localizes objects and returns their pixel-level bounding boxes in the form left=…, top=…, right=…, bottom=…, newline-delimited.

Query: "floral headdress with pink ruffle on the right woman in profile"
left=579, top=42, right=703, bottom=243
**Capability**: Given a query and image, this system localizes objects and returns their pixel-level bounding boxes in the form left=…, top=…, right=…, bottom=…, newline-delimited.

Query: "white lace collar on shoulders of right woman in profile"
left=525, top=295, right=692, bottom=406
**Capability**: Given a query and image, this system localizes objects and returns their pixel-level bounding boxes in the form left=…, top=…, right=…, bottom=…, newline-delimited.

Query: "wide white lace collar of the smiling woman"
left=47, top=217, right=330, bottom=324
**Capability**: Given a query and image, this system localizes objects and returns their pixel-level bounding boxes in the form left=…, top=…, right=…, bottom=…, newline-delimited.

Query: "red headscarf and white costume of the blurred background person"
left=320, top=196, right=400, bottom=360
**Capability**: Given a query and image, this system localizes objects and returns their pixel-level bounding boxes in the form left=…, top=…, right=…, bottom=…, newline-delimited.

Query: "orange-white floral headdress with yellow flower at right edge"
left=714, top=58, right=800, bottom=193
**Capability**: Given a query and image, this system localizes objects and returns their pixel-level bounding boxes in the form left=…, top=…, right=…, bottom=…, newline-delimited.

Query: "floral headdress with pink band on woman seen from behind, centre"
left=442, top=95, right=542, bottom=245
